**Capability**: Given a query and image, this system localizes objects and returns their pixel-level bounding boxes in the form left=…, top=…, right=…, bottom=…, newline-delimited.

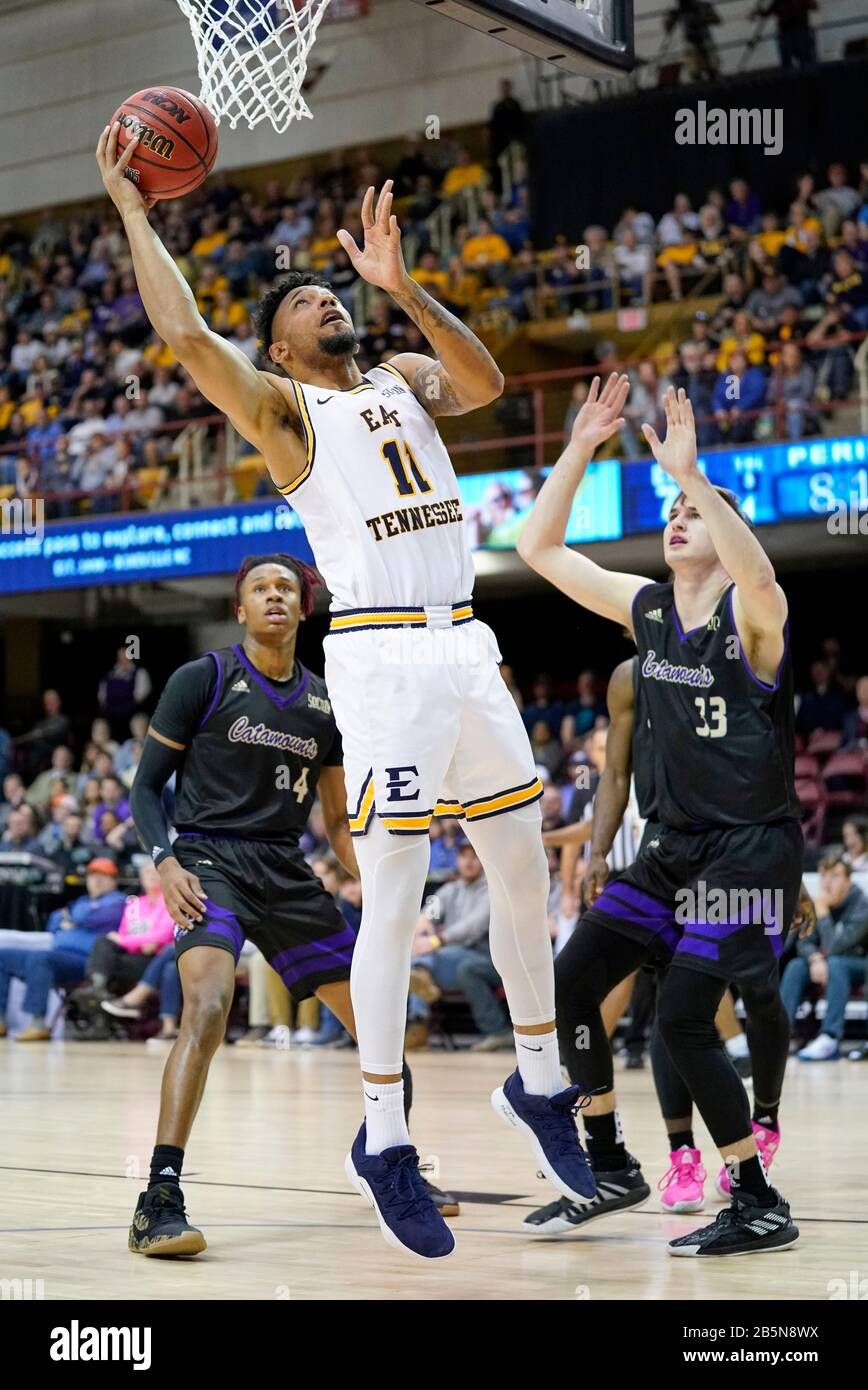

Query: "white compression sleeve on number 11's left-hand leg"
left=351, top=817, right=431, bottom=1076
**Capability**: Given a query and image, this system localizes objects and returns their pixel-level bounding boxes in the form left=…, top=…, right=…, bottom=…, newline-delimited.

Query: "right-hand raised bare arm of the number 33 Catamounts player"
left=643, top=386, right=787, bottom=642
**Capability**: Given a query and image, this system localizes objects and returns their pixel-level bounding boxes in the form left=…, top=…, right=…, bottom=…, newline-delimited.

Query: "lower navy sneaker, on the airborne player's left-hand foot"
left=344, top=1123, right=455, bottom=1259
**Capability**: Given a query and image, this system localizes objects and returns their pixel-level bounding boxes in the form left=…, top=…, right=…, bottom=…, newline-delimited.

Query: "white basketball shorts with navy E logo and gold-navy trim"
left=324, top=603, right=543, bottom=835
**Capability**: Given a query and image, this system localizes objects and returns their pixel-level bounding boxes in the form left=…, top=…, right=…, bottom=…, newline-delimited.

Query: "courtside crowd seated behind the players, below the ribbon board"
left=0, top=638, right=868, bottom=1061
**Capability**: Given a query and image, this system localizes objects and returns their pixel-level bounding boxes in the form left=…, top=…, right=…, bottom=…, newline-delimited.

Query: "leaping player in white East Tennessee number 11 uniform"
left=97, top=128, right=595, bottom=1259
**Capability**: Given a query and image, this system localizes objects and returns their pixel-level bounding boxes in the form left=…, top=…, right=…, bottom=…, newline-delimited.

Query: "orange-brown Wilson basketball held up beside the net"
left=111, top=88, right=217, bottom=199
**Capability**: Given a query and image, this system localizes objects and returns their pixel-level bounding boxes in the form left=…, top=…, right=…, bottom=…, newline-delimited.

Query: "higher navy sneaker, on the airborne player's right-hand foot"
left=491, top=1070, right=597, bottom=1201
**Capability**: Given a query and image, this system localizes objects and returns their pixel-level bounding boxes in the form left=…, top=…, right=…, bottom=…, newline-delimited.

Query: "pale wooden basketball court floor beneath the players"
left=0, top=1040, right=868, bottom=1301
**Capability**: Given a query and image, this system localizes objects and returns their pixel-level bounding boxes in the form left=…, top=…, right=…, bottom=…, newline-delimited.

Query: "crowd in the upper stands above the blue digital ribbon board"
left=0, top=102, right=868, bottom=518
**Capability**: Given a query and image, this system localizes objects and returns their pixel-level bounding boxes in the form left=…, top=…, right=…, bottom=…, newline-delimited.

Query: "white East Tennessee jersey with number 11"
left=272, top=363, right=473, bottom=609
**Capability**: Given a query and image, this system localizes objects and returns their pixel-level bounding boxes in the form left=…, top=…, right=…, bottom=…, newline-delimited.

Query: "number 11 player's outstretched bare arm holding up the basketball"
left=96, top=122, right=289, bottom=450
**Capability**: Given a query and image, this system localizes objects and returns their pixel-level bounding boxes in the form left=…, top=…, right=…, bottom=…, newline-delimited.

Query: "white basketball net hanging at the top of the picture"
left=178, top=0, right=335, bottom=135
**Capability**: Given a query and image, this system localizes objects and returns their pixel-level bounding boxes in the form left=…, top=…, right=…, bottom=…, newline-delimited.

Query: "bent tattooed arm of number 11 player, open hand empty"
left=338, top=179, right=504, bottom=416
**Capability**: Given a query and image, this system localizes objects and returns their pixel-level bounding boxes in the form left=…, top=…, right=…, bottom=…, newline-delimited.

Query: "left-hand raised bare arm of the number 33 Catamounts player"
left=517, top=374, right=650, bottom=630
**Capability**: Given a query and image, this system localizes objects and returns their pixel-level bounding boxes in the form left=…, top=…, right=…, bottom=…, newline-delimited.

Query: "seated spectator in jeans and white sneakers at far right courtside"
left=780, top=849, right=868, bottom=1062
